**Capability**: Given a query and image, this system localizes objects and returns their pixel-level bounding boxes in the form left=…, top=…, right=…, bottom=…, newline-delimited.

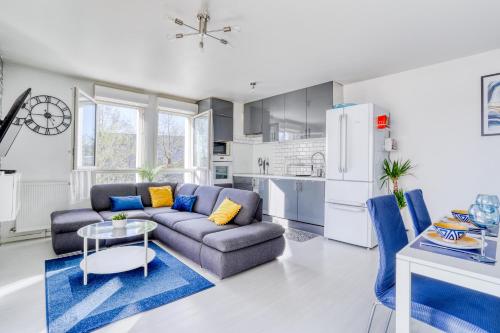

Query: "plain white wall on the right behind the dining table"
left=344, top=49, right=500, bottom=218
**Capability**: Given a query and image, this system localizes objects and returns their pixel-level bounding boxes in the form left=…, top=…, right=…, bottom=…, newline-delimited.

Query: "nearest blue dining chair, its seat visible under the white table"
left=367, top=195, right=500, bottom=332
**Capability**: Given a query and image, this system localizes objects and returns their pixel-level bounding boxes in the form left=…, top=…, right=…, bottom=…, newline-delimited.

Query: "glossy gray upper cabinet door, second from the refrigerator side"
left=284, top=89, right=307, bottom=140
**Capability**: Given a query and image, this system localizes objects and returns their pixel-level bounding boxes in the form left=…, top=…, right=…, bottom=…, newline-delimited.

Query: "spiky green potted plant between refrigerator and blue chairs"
left=380, top=158, right=414, bottom=229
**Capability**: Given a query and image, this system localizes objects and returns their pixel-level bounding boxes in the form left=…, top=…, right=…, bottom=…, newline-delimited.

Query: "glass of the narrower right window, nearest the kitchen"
left=156, top=112, right=189, bottom=169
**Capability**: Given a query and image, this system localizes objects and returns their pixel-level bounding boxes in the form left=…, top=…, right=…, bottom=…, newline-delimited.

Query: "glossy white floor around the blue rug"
left=0, top=237, right=435, bottom=333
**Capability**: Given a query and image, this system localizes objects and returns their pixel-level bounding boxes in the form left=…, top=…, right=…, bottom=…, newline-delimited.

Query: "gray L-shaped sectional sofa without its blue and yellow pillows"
left=51, top=183, right=285, bottom=278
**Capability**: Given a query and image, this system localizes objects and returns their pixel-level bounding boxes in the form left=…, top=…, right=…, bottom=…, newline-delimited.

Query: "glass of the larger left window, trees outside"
left=96, top=104, right=139, bottom=170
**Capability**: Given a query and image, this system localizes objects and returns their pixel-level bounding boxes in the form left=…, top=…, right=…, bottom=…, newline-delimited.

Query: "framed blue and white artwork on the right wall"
left=481, top=73, right=500, bottom=136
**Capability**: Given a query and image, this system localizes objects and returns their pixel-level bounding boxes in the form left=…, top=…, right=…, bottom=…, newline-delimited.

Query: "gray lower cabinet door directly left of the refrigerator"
left=297, top=180, right=325, bottom=226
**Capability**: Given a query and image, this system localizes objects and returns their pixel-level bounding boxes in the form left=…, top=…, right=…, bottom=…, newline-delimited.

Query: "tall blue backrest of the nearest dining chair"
left=366, top=194, right=408, bottom=299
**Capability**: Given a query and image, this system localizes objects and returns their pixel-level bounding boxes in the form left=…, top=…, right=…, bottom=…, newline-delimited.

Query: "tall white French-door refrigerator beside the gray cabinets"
left=324, top=104, right=388, bottom=248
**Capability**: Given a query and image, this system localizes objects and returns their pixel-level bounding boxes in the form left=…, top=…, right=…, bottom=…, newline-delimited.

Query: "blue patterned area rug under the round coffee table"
left=45, top=242, right=214, bottom=333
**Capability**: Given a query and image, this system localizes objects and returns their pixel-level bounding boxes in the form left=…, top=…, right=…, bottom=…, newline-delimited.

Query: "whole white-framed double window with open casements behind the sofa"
left=74, top=85, right=199, bottom=184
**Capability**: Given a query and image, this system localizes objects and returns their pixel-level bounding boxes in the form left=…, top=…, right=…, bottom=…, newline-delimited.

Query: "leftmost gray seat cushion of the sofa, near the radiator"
left=50, top=208, right=102, bottom=233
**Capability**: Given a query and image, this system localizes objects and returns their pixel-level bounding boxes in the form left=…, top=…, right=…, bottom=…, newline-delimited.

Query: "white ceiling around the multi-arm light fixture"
left=0, top=0, right=500, bottom=101
